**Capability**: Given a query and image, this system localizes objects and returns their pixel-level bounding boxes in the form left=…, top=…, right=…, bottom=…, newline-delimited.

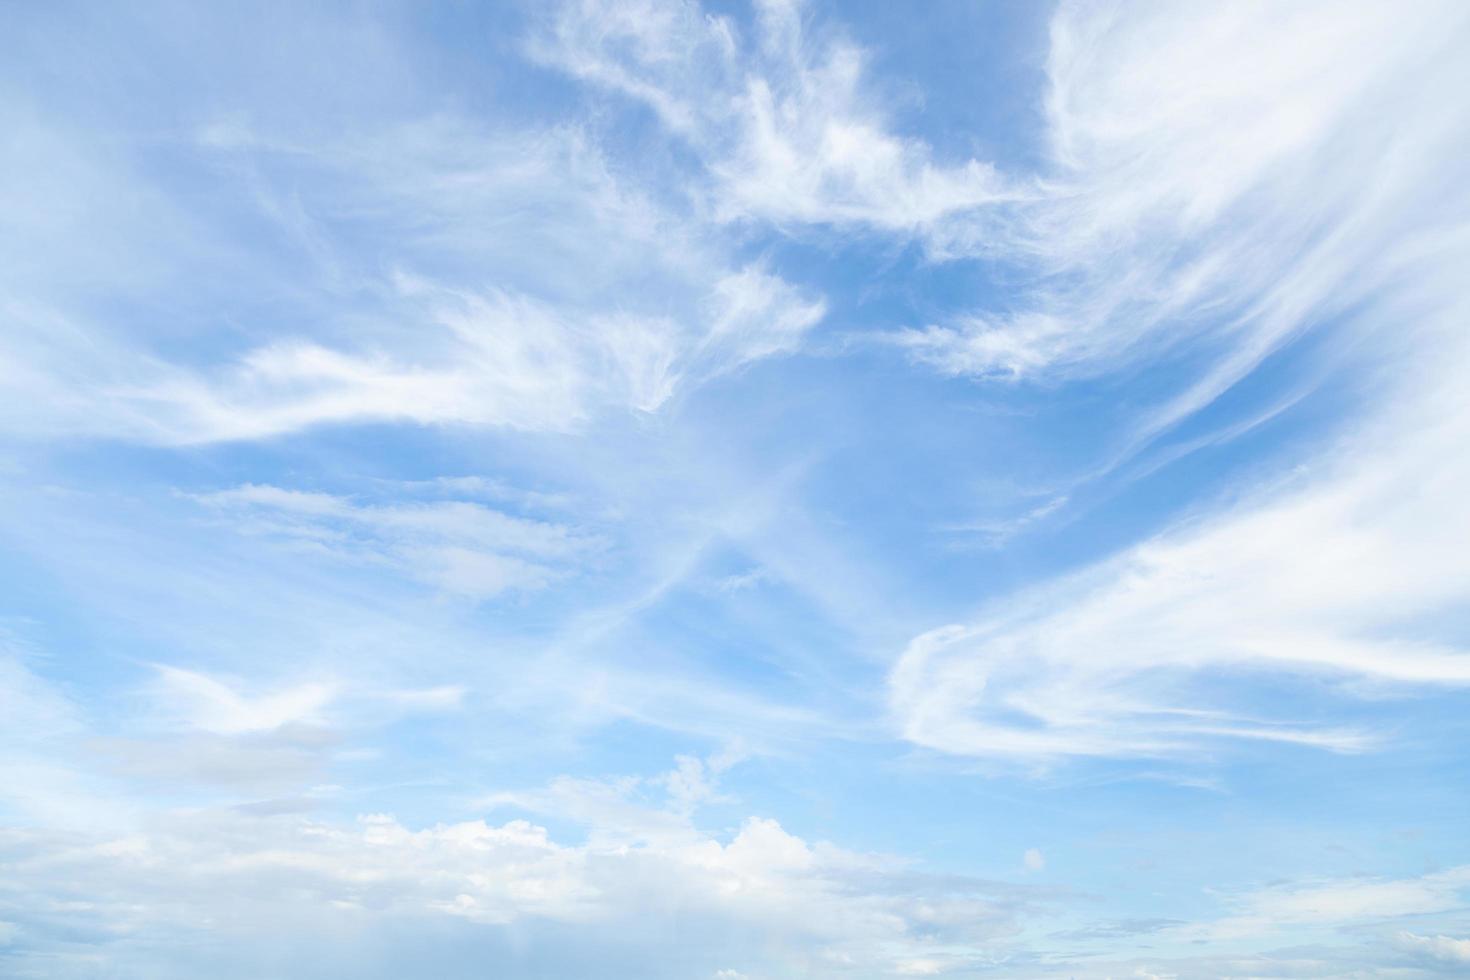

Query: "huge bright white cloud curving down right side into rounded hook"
left=889, top=6, right=1470, bottom=760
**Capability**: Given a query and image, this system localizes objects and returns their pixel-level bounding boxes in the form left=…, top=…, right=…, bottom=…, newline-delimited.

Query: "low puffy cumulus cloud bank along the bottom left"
left=0, top=764, right=1034, bottom=976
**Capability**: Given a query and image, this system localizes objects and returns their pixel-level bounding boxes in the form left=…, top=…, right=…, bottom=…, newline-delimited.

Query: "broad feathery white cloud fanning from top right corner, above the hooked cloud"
left=900, top=3, right=1467, bottom=433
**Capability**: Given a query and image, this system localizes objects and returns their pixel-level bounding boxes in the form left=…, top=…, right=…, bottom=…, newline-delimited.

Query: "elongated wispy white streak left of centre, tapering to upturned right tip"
left=107, top=266, right=825, bottom=444
